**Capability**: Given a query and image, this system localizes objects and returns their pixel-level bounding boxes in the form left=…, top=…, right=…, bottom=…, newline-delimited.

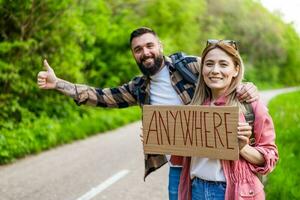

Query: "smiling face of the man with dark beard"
left=131, top=33, right=163, bottom=75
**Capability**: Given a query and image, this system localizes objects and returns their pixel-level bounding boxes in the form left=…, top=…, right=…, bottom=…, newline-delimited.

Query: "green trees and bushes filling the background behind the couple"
left=0, top=0, right=300, bottom=162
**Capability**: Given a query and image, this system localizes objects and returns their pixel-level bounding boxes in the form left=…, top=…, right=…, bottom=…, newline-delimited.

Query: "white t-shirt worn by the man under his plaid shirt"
left=150, top=66, right=183, bottom=167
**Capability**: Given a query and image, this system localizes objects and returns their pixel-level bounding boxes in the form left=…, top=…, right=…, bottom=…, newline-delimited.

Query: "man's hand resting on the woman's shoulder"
left=236, top=83, right=259, bottom=103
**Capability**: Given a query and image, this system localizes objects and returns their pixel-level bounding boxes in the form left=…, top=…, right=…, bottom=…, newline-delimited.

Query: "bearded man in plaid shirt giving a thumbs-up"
left=38, top=27, right=257, bottom=199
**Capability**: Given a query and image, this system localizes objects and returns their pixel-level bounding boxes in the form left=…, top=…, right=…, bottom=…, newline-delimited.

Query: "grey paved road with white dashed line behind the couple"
left=0, top=88, right=297, bottom=200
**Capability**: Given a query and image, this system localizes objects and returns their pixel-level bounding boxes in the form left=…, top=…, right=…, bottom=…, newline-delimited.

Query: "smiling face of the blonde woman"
left=202, top=48, right=239, bottom=97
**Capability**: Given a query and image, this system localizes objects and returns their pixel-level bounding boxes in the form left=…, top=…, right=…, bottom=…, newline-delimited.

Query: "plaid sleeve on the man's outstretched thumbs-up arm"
left=75, top=77, right=139, bottom=108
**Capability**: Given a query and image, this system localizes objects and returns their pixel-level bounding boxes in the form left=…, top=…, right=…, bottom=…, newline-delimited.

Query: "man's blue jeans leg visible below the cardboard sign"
left=168, top=167, right=182, bottom=200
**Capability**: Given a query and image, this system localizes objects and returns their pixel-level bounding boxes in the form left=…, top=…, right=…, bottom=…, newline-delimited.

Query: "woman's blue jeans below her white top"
left=192, top=178, right=226, bottom=200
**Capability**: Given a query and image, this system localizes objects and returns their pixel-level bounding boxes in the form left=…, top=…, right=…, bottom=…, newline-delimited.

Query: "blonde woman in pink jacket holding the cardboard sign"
left=179, top=40, right=278, bottom=200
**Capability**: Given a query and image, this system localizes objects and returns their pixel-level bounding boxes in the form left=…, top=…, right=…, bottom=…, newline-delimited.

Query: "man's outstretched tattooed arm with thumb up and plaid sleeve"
left=38, top=60, right=136, bottom=108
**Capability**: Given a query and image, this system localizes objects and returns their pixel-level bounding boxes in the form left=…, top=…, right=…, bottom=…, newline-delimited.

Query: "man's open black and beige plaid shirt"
left=75, top=56, right=200, bottom=178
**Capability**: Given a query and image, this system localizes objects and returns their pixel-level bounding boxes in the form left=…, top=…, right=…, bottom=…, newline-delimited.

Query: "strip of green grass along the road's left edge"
left=0, top=107, right=141, bottom=164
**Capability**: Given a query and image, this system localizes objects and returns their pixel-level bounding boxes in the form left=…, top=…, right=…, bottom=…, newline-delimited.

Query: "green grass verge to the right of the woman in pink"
left=265, top=91, right=300, bottom=200
